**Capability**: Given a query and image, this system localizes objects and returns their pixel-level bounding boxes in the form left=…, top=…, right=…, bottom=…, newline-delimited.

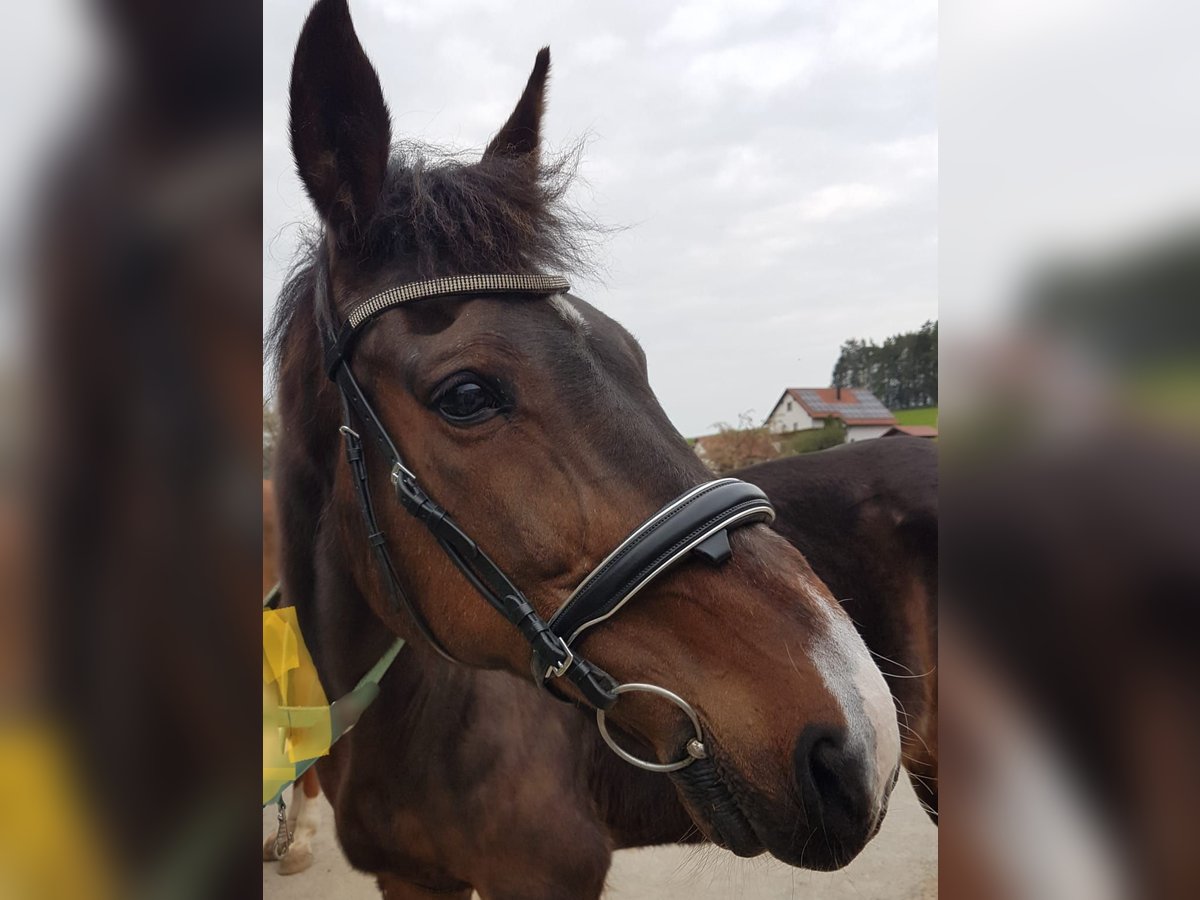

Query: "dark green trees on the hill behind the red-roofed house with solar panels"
left=833, top=322, right=937, bottom=409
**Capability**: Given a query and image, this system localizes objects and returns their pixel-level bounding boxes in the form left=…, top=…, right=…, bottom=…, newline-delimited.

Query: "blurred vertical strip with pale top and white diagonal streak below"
left=938, top=0, right=1200, bottom=898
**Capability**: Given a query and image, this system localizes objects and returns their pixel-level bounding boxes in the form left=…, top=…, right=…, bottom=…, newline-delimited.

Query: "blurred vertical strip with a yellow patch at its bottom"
left=0, top=0, right=262, bottom=898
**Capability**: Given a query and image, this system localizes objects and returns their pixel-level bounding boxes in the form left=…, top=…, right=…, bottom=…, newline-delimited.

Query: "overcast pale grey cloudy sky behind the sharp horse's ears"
left=263, top=0, right=937, bottom=436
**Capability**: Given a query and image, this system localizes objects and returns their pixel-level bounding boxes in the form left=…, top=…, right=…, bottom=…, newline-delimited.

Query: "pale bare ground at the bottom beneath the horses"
left=263, top=776, right=937, bottom=900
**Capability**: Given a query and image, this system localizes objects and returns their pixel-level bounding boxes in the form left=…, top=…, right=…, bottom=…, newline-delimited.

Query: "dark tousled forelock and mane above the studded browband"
left=266, top=142, right=604, bottom=373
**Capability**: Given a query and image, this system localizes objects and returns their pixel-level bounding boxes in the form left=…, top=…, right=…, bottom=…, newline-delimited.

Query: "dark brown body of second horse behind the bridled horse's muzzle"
left=734, top=437, right=937, bottom=822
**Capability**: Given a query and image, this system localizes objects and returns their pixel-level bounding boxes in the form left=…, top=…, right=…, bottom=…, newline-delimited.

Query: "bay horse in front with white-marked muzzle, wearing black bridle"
left=267, top=0, right=899, bottom=899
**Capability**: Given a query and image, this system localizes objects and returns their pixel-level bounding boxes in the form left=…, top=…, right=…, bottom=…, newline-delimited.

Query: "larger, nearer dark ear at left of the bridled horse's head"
left=289, top=0, right=391, bottom=244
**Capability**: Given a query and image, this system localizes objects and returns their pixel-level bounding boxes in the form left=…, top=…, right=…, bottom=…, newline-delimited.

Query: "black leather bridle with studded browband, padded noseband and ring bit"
left=316, top=260, right=775, bottom=772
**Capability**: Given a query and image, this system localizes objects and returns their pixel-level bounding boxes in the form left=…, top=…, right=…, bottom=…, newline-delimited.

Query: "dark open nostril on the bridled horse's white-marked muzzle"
left=796, top=725, right=875, bottom=852
